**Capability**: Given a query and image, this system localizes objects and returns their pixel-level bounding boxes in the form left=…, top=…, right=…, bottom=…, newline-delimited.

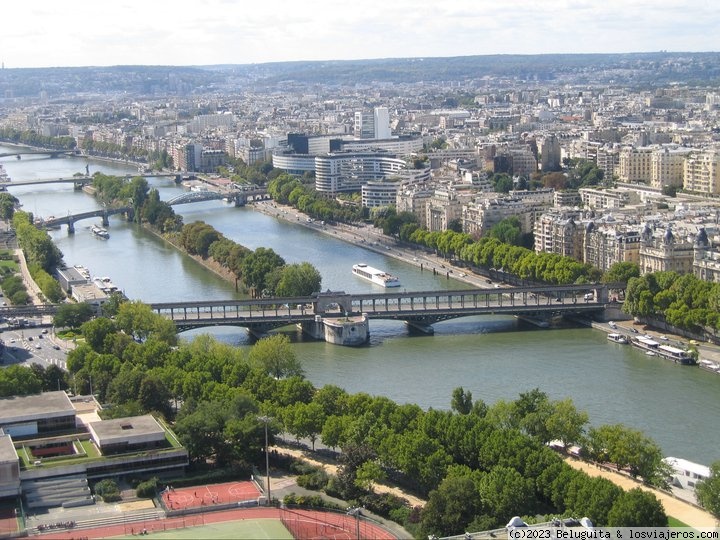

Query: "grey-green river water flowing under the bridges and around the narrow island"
left=0, top=146, right=720, bottom=464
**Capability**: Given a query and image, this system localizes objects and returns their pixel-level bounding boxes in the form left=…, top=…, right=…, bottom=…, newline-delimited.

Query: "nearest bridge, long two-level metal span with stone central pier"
left=151, top=284, right=625, bottom=342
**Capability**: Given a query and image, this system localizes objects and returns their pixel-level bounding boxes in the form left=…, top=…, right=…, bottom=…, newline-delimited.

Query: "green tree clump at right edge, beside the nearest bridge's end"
left=623, top=272, right=720, bottom=334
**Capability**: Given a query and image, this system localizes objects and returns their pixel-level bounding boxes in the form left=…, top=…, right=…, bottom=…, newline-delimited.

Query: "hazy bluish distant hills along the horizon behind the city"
left=0, top=52, right=720, bottom=98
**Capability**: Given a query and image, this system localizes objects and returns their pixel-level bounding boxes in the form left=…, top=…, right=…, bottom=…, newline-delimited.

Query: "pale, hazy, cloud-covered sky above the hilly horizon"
left=0, top=0, right=720, bottom=68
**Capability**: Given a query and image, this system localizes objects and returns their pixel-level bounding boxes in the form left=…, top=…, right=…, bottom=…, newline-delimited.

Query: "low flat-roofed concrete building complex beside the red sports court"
left=0, top=391, right=188, bottom=509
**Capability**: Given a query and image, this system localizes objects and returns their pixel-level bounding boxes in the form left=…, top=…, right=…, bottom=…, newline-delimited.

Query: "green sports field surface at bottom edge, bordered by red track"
left=115, top=516, right=293, bottom=540
